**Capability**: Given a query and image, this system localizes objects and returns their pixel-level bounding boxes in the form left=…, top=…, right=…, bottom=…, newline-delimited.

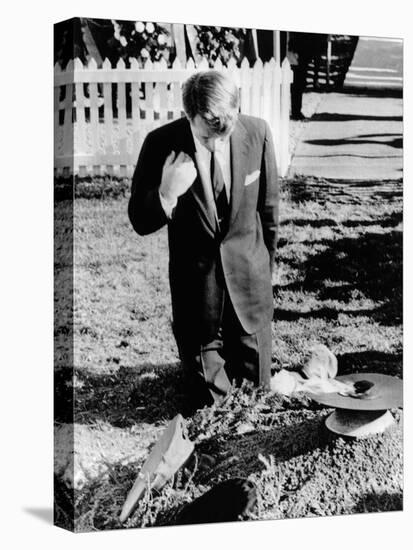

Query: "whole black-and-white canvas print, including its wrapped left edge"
left=54, top=16, right=403, bottom=532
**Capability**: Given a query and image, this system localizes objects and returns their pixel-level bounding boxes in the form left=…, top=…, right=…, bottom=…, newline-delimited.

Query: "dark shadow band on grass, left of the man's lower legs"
left=55, top=363, right=183, bottom=428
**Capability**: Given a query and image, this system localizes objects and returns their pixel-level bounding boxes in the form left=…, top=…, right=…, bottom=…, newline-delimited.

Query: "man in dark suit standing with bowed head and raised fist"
left=129, top=71, right=279, bottom=409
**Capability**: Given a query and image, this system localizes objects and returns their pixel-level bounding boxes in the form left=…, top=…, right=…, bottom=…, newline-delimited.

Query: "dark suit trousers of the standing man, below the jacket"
left=177, top=291, right=271, bottom=412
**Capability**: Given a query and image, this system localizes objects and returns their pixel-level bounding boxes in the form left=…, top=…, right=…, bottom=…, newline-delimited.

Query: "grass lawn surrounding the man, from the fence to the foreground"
left=55, top=178, right=403, bottom=531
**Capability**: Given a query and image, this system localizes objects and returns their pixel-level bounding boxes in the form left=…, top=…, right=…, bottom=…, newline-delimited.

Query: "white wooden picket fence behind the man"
left=54, top=55, right=292, bottom=177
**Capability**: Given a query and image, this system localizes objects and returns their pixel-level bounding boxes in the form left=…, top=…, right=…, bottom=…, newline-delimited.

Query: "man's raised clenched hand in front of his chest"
left=159, top=151, right=196, bottom=203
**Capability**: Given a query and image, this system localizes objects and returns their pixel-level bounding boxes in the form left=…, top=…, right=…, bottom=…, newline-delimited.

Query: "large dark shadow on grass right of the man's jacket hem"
left=274, top=229, right=402, bottom=325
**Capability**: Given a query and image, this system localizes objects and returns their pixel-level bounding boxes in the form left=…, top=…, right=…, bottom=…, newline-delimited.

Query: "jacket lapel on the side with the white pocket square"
left=229, top=120, right=248, bottom=227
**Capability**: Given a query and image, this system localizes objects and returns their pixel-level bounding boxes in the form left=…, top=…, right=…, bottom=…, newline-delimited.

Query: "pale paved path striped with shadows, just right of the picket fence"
left=289, top=93, right=403, bottom=180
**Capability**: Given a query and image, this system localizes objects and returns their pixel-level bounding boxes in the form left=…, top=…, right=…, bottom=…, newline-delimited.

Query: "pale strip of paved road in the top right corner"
left=344, top=36, right=403, bottom=90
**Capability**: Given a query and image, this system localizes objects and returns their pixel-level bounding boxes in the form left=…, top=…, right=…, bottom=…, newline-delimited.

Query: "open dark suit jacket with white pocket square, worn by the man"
left=129, top=115, right=279, bottom=342
